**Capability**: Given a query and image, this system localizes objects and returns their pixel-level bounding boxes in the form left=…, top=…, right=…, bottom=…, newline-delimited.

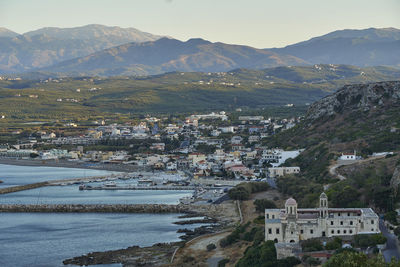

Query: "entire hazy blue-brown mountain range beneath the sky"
left=0, top=25, right=400, bottom=76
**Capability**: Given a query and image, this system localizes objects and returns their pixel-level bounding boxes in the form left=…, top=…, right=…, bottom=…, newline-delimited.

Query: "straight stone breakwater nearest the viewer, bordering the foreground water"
left=0, top=204, right=194, bottom=213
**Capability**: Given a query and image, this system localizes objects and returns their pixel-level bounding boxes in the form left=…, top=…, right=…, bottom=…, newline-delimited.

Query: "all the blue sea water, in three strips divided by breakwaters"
left=0, top=165, right=199, bottom=267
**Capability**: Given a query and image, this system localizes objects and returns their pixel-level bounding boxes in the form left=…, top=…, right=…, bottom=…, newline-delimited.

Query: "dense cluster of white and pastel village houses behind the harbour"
left=0, top=112, right=301, bottom=180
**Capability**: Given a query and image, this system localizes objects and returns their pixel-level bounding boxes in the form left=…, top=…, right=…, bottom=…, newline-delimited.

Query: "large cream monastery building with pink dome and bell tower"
left=265, top=193, right=380, bottom=243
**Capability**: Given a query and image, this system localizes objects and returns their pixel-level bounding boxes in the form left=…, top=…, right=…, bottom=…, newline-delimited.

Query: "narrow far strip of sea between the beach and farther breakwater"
left=0, top=164, right=116, bottom=188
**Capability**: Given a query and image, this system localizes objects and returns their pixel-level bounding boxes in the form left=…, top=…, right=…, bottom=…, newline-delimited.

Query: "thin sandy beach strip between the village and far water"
left=0, top=158, right=147, bottom=172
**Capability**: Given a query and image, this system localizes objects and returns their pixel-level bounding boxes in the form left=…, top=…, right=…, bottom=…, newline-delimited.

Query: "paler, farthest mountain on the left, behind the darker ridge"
left=0, top=24, right=161, bottom=74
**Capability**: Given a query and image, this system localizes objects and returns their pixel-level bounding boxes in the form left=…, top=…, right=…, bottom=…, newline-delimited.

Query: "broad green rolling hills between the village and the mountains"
left=0, top=65, right=400, bottom=119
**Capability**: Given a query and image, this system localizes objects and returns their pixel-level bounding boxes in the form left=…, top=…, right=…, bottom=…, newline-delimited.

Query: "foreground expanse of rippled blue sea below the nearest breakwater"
left=0, top=213, right=199, bottom=267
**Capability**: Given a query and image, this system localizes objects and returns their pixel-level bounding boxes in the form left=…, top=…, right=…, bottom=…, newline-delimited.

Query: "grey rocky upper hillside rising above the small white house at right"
left=268, top=81, right=400, bottom=155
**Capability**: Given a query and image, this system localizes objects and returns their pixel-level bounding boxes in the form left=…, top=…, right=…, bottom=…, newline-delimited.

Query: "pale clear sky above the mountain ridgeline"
left=0, top=0, right=400, bottom=48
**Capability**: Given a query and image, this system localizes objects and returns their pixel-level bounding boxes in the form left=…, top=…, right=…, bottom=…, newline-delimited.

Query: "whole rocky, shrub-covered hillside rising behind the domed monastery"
left=272, top=81, right=400, bottom=210
